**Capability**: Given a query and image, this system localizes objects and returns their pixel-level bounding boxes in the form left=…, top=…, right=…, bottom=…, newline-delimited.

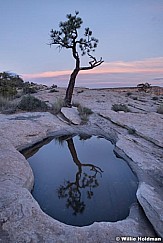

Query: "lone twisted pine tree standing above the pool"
left=50, top=11, right=104, bottom=107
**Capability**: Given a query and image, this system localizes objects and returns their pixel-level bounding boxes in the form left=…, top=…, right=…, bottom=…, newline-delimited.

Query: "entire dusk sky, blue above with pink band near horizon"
left=0, top=0, right=163, bottom=88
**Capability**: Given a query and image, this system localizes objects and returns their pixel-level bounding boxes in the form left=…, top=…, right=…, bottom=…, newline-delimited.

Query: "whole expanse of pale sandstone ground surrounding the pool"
left=0, top=88, right=163, bottom=243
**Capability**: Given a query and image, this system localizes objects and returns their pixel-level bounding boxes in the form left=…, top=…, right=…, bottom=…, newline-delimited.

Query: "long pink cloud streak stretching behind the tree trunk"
left=23, top=57, right=163, bottom=79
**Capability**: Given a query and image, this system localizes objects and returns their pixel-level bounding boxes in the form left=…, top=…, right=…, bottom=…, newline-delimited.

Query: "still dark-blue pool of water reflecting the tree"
left=24, top=136, right=137, bottom=226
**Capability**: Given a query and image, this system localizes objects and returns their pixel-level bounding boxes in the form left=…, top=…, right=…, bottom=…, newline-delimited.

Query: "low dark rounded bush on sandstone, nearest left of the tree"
left=18, top=95, right=48, bottom=111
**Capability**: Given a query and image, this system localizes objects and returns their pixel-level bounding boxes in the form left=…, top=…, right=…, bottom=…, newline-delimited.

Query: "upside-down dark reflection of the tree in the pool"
left=57, top=138, right=103, bottom=215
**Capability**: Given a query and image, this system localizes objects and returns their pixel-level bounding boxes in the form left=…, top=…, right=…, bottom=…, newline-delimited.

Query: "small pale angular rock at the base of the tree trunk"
left=61, top=107, right=81, bottom=125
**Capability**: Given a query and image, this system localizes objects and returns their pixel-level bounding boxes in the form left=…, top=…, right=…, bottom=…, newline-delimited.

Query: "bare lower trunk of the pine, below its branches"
left=64, top=68, right=80, bottom=107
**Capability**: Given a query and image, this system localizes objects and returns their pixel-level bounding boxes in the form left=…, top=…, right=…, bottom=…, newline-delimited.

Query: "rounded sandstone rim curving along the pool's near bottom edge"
left=0, top=180, right=155, bottom=243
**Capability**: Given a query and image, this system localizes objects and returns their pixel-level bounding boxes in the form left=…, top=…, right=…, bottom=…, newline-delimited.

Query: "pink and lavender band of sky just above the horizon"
left=22, top=57, right=163, bottom=87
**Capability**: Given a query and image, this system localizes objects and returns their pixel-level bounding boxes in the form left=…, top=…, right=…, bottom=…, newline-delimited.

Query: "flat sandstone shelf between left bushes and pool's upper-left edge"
left=0, top=112, right=67, bottom=150
